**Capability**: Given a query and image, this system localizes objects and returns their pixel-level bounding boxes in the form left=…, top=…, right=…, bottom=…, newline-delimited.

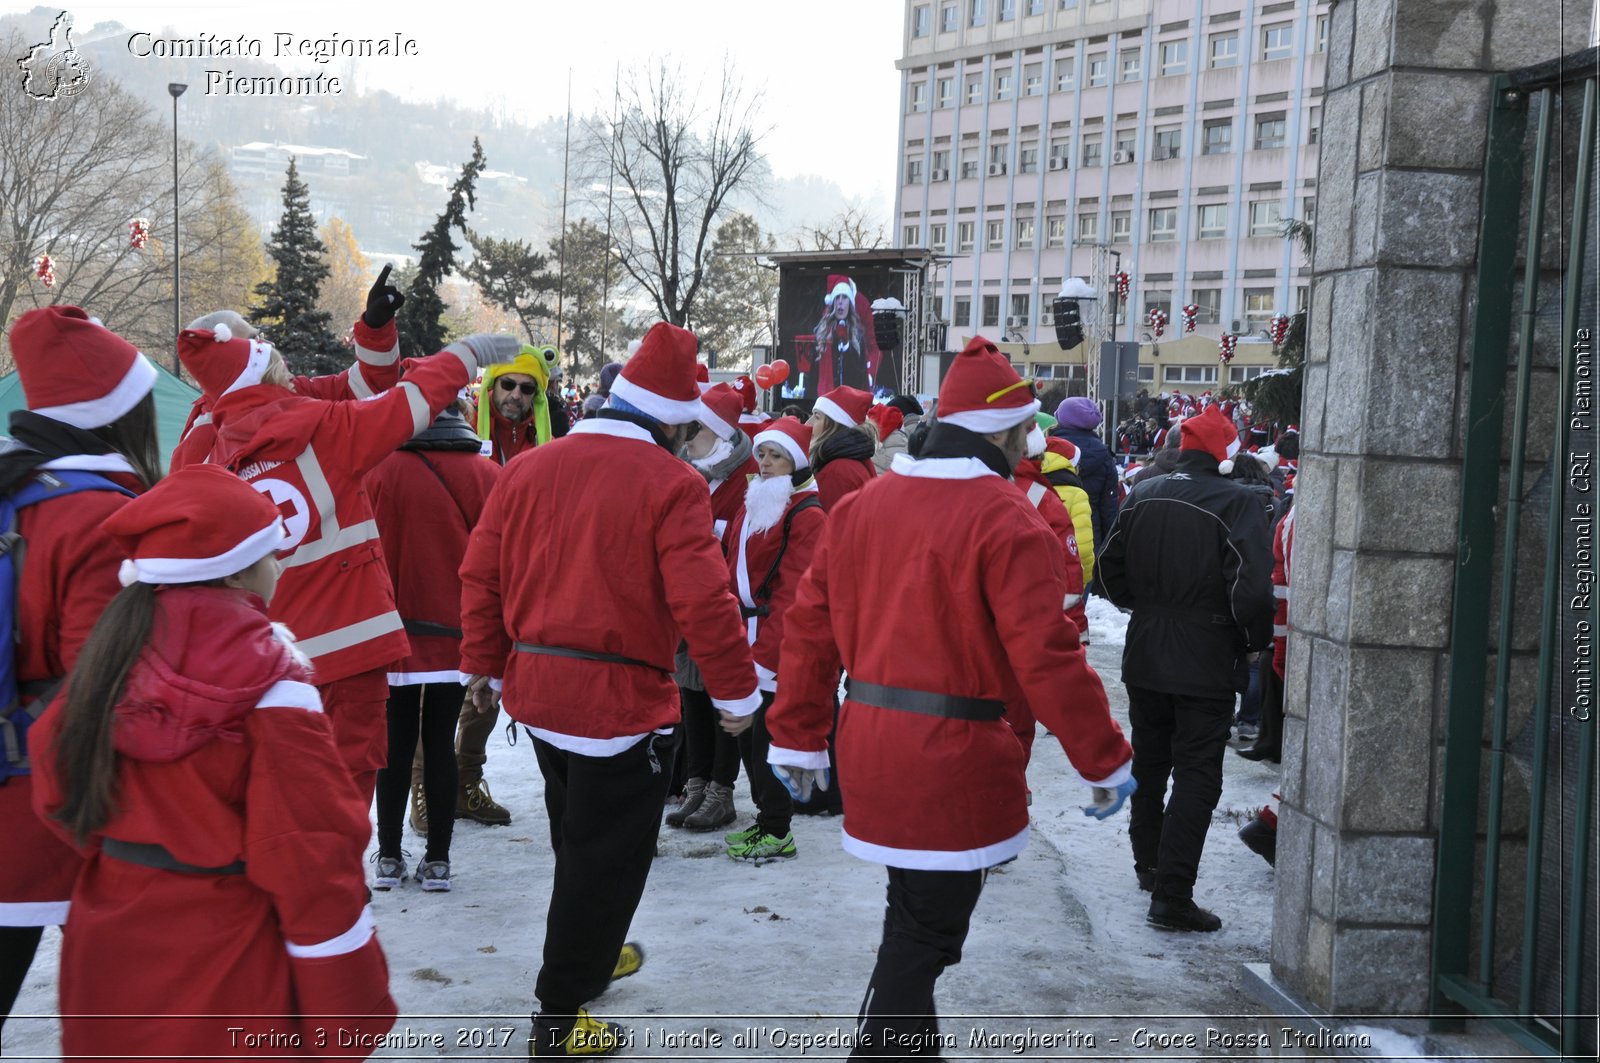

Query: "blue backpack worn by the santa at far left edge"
left=0, top=469, right=133, bottom=784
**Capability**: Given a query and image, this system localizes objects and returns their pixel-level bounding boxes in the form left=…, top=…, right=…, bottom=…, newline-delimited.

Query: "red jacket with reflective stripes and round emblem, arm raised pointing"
left=211, top=322, right=477, bottom=685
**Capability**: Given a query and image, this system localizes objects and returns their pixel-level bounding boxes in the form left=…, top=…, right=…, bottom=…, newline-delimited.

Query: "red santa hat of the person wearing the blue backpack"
left=11, top=306, right=155, bottom=429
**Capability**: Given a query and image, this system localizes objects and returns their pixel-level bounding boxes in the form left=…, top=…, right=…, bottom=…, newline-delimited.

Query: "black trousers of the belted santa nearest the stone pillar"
left=850, top=868, right=986, bottom=1060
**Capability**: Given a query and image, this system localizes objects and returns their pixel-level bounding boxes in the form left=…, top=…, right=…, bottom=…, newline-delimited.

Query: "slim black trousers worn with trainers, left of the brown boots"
left=378, top=684, right=462, bottom=860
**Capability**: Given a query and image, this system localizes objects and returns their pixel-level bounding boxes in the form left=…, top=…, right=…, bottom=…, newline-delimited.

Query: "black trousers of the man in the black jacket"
left=1125, top=684, right=1234, bottom=900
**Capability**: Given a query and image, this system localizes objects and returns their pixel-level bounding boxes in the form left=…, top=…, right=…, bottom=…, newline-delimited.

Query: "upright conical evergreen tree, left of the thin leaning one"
left=250, top=157, right=342, bottom=375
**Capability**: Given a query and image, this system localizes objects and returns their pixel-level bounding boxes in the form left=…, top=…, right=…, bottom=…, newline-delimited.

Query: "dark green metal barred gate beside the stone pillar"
left=1432, top=48, right=1600, bottom=1058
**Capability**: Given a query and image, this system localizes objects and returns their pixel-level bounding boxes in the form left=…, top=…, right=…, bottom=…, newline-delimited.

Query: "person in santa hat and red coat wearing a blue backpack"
left=0, top=306, right=162, bottom=1043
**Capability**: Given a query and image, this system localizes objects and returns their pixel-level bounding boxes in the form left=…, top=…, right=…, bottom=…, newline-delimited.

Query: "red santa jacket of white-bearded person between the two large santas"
left=722, top=482, right=826, bottom=693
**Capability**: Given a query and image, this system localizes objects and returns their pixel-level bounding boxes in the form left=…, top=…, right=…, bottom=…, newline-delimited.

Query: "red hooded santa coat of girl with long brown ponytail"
left=32, top=586, right=395, bottom=1058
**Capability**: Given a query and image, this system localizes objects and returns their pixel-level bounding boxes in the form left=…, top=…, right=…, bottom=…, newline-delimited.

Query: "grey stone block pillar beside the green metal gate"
left=1272, top=0, right=1589, bottom=1013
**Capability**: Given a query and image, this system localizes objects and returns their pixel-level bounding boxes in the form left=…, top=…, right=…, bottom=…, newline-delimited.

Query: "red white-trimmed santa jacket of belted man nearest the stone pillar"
left=766, top=455, right=1133, bottom=871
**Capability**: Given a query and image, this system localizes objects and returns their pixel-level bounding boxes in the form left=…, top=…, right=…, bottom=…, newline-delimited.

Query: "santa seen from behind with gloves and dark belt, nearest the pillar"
left=766, top=338, right=1134, bottom=1057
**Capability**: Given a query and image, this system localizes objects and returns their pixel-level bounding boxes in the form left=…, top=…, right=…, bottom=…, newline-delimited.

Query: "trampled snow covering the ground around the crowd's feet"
left=5, top=599, right=1277, bottom=1060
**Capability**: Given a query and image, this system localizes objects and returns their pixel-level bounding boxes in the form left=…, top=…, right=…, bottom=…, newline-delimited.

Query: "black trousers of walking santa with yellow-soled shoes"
left=533, top=733, right=677, bottom=1045
